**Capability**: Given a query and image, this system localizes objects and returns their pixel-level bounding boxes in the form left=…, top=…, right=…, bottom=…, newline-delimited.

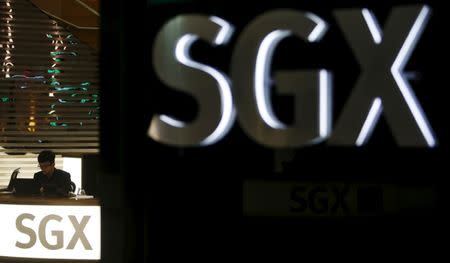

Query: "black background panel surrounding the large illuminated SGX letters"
left=100, top=0, right=449, bottom=262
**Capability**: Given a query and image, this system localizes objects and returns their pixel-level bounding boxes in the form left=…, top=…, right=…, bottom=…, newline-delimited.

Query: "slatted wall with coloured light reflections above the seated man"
left=0, top=0, right=100, bottom=156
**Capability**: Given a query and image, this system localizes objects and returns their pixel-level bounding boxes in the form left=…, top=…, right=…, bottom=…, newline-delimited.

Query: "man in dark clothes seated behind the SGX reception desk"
left=34, top=150, right=71, bottom=196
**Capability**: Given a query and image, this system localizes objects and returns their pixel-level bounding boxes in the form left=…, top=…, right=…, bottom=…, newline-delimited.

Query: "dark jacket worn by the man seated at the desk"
left=34, top=169, right=71, bottom=196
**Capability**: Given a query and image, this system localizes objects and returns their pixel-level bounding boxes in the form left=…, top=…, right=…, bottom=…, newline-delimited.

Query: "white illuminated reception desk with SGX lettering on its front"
left=0, top=194, right=101, bottom=262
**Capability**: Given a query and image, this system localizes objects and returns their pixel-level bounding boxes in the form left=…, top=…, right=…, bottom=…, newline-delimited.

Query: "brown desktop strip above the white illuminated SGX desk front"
left=0, top=194, right=99, bottom=206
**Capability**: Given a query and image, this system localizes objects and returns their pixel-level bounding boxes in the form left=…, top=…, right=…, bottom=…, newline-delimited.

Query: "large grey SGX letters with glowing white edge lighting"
left=148, top=6, right=437, bottom=147
